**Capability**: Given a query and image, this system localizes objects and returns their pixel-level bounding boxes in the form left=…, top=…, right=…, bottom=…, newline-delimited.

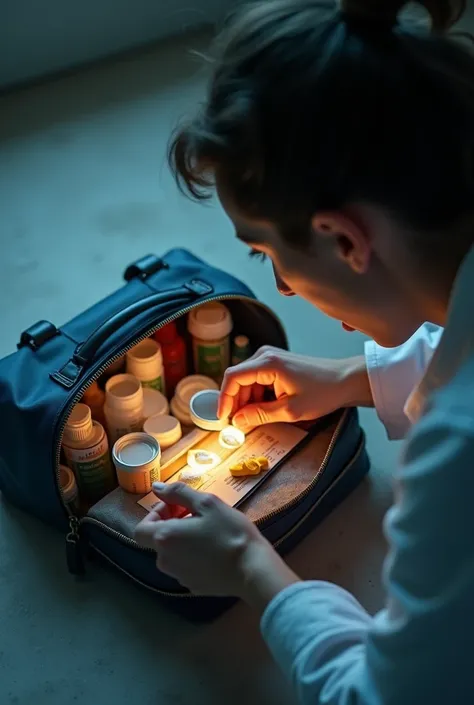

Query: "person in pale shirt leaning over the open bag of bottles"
left=137, top=0, right=474, bottom=705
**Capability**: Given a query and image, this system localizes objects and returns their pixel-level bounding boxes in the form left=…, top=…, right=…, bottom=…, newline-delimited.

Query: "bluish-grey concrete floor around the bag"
left=0, top=31, right=398, bottom=705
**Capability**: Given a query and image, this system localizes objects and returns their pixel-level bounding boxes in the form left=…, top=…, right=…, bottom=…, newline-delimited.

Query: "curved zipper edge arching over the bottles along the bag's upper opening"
left=55, top=294, right=288, bottom=516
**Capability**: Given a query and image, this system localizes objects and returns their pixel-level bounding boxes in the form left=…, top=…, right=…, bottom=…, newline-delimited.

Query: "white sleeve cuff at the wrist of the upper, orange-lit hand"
left=365, top=323, right=443, bottom=440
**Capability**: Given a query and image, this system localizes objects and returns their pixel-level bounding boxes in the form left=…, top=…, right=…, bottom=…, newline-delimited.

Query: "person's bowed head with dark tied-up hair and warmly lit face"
left=170, top=0, right=474, bottom=346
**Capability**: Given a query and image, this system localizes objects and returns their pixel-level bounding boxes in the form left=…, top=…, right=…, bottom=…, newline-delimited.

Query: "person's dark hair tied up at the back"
left=169, top=0, right=474, bottom=245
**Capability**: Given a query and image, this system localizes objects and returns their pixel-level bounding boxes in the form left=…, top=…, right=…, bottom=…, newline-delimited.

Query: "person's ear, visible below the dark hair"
left=311, top=211, right=371, bottom=274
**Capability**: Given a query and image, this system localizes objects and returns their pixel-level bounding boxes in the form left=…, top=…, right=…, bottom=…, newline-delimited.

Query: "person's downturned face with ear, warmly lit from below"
left=218, top=183, right=423, bottom=347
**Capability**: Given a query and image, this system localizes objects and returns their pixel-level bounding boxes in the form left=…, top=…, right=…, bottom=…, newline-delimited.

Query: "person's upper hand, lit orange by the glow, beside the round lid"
left=219, top=346, right=373, bottom=431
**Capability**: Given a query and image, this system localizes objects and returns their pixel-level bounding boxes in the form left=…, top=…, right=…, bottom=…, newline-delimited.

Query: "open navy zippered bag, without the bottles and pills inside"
left=0, top=249, right=369, bottom=619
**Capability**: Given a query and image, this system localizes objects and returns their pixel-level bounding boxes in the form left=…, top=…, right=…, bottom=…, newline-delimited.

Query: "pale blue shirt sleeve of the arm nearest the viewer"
left=262, top=412, right=474, bottom=705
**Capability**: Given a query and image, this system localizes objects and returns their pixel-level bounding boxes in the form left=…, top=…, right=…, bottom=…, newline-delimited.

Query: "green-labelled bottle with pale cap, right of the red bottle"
left=188, top=302, right=232, bottom=383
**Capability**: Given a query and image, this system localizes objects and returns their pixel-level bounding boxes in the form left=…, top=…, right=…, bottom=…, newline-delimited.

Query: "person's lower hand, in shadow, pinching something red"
left=135, top=482, right=298, bottom=609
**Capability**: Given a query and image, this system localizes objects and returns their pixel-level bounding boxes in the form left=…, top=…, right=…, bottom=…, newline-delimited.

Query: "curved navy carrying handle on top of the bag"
left=50, top=279, right=214, bottom=389
